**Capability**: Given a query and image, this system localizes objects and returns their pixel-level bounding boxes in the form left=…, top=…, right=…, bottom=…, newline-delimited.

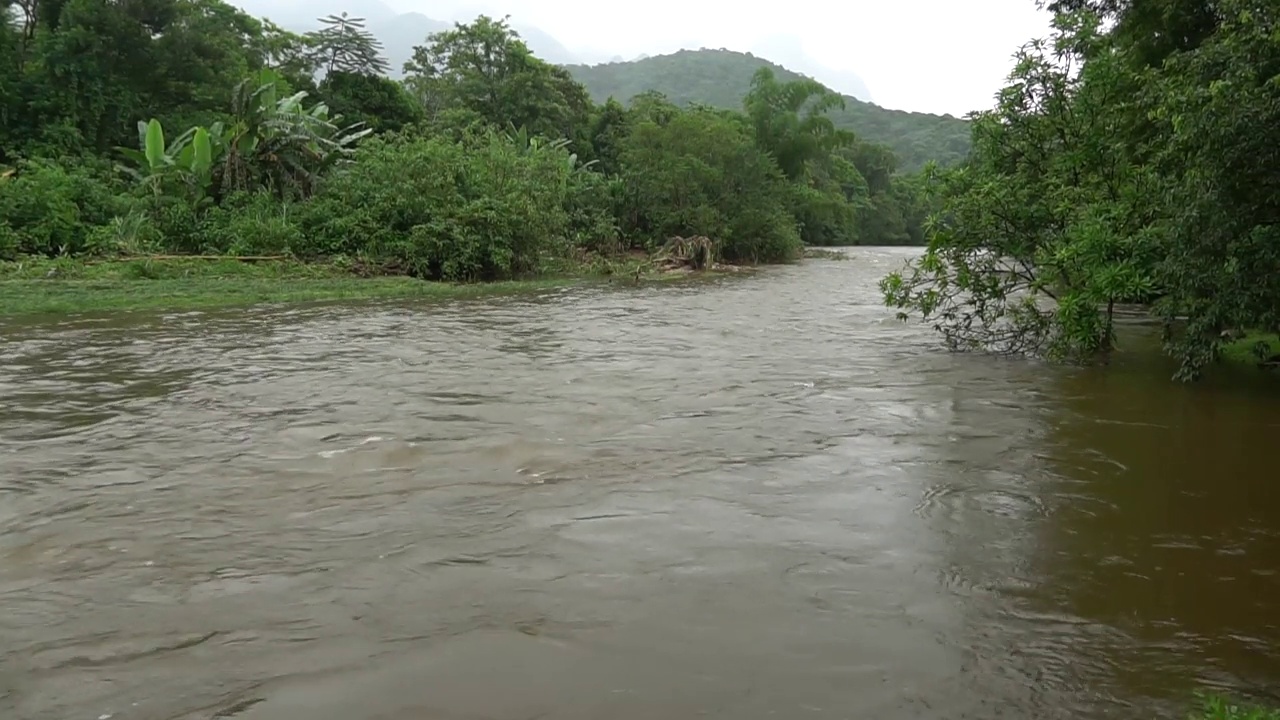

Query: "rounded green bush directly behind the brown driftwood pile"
left=620, top=110, right=801, bottom=263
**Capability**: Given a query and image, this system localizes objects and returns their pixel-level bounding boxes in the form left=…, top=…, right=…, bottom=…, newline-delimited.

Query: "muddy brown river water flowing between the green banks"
left=0, top=250, right=1280, bottom=720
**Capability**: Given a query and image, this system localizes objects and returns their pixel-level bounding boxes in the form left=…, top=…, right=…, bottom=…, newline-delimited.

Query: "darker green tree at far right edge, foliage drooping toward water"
left=1152, top=0, right=1280, bottom=368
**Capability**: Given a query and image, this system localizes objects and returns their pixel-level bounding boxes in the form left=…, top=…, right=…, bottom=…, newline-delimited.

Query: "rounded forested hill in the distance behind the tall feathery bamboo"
left=568, top=50, right=969, bottom=172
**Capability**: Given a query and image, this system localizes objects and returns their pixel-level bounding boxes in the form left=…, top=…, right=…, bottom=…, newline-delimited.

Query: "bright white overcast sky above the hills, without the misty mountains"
left=387, top=0, right=1050, bottom=115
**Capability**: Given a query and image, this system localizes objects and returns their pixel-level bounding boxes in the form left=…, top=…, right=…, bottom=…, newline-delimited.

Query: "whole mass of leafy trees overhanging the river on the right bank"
left=883, top=0, right=1280, bottom=378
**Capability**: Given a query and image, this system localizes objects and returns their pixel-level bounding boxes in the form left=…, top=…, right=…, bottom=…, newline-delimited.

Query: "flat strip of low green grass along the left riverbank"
left=0, top=259, right=582, bottom=315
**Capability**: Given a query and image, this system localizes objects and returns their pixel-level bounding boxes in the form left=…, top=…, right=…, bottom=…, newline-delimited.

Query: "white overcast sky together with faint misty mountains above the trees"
left=227, top=0, right=1050, bottom=117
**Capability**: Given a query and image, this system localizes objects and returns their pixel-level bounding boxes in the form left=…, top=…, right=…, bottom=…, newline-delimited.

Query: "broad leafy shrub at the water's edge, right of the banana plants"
left=300, top=133, right=573, bottom=281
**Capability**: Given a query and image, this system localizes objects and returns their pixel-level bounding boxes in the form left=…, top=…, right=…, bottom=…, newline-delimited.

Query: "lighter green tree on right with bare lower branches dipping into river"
left=882, top=12, right=1155, bottom=359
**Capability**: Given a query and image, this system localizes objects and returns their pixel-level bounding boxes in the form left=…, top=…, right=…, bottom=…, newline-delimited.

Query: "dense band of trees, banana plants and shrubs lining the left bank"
left=0, top=0, right=942, bottom=297
